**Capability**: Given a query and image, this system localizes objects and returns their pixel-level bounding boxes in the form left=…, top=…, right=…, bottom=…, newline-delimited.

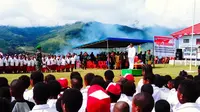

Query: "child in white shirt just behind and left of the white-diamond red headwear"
left=79, top=73, right=94, bottom=112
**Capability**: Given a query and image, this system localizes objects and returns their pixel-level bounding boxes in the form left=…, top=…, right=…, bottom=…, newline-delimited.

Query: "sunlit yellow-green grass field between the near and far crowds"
left=0, top=65, right=197, bottom=83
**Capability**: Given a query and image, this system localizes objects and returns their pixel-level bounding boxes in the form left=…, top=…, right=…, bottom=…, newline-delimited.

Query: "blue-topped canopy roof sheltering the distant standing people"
left=74, top=37, right=153, bottom=48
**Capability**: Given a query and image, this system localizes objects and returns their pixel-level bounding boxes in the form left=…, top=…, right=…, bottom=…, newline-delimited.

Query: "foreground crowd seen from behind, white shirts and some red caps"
left=0, top=65, right=200, bottom=112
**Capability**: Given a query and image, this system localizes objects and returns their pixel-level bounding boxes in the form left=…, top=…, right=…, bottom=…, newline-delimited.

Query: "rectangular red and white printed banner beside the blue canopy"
left=154, top=36, right=176, bottom=57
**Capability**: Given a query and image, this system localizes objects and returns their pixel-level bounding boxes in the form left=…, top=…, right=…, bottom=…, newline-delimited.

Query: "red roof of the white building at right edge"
left=171, top=23, right=200, bottom=38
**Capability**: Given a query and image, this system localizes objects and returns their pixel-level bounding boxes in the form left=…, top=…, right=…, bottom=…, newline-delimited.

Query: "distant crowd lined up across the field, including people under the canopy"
left=0, top=51, right=153, bottom=74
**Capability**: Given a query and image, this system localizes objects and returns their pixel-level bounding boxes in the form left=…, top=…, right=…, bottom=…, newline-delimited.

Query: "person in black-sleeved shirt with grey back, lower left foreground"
left=10, top=79, right=35, bottom=112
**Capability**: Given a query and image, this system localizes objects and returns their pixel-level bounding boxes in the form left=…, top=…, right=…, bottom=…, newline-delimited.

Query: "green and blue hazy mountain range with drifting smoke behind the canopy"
left=0, top=22, right=178, bottom=54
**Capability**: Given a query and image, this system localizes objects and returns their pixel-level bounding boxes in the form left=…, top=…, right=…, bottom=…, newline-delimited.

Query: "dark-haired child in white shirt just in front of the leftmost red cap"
left=47, top=80, right=61, bottom=109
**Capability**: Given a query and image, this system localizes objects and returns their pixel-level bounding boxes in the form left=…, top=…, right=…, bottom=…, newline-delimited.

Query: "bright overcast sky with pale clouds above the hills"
left=0, top=0, right=200, bottom=28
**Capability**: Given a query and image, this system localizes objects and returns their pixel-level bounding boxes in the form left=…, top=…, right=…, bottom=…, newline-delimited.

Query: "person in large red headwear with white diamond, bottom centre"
left=86, top=84, right=111, bottom=112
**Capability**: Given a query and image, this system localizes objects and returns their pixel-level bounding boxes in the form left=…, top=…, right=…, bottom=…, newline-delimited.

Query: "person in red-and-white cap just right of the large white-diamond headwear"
left=106, top=83, right=121, bottom=112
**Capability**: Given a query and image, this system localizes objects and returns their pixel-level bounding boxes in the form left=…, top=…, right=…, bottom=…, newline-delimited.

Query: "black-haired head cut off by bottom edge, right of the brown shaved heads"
left=155, top=100, right=170, bottom=112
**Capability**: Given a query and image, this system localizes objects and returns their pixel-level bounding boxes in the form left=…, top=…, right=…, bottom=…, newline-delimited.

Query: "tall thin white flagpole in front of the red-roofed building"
left=190, top=0, right=196, bottom=71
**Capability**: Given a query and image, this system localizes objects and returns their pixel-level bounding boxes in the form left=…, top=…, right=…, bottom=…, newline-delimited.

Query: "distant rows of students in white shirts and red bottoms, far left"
left=0, top=53, right=77, bottom=74
